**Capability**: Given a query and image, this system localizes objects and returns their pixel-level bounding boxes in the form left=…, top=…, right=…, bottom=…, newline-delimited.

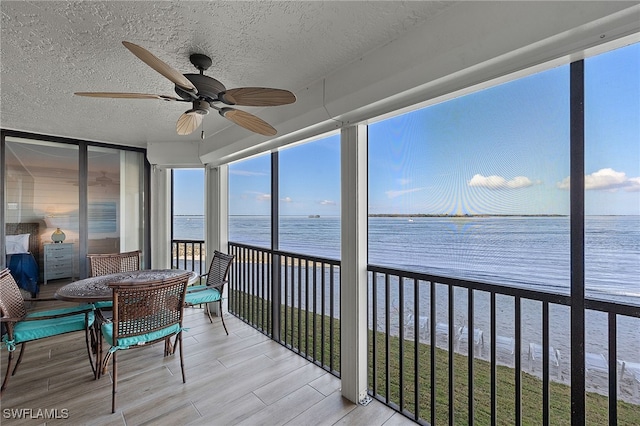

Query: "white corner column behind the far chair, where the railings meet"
left=204, top=164, right=229, bottom=315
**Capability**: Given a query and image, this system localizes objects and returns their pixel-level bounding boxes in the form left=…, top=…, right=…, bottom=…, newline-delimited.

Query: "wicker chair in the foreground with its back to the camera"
left=101, top=273, right=191, bottom=413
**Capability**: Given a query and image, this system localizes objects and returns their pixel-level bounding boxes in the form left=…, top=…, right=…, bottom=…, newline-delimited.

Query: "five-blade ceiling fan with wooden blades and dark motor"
left=75, top=41, right=296, bottom=138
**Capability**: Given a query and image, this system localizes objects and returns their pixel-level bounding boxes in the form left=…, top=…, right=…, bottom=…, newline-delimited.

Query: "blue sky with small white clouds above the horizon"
left=175, top=44, right=640, bottom=215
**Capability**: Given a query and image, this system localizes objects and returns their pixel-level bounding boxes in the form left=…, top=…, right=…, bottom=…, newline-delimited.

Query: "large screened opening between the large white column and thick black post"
left=368, top=66, right=571, bottom=424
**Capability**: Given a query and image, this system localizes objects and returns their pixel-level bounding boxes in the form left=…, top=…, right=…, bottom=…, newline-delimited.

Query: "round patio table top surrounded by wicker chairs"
left=53, top=269, right=199, bottom=303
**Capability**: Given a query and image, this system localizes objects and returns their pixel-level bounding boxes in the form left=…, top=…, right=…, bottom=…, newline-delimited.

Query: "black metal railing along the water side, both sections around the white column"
left=229, top=243, right=640, bottom=425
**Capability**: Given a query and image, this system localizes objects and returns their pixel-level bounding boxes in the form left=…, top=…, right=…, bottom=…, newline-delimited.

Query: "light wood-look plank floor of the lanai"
left=0, top=281, right=414, bottom=426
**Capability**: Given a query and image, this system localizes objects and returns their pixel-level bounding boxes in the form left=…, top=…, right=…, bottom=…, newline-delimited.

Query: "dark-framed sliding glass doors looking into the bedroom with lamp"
left=3, top=136, right=145, bottom=282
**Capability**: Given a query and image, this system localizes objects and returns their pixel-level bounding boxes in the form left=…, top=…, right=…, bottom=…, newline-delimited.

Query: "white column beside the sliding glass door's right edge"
left=150, top=166, right=171, bottom=269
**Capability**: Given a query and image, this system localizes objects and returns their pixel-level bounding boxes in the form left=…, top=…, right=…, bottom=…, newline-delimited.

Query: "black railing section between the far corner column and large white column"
left=229, top=243, right=340, bottom=377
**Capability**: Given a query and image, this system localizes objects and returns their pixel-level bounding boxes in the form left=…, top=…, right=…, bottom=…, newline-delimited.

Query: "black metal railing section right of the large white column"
left=368, top=265, right=640, bottom=425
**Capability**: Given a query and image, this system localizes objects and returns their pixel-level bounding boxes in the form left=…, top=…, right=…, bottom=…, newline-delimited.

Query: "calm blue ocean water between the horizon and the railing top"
left=174, top=216, right=640, bottom=305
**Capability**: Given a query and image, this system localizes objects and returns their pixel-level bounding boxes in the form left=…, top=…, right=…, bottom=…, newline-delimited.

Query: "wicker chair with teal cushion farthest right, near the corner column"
left=185, top=250, right=235, bottom=335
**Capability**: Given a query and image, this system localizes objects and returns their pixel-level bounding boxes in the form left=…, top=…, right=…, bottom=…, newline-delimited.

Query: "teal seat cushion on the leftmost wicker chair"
left=2, top=305, right=95, bottom=345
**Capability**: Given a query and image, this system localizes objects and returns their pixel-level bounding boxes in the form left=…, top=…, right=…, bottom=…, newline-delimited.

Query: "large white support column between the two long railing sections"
left=340, top=125, right=368, bottom=403
